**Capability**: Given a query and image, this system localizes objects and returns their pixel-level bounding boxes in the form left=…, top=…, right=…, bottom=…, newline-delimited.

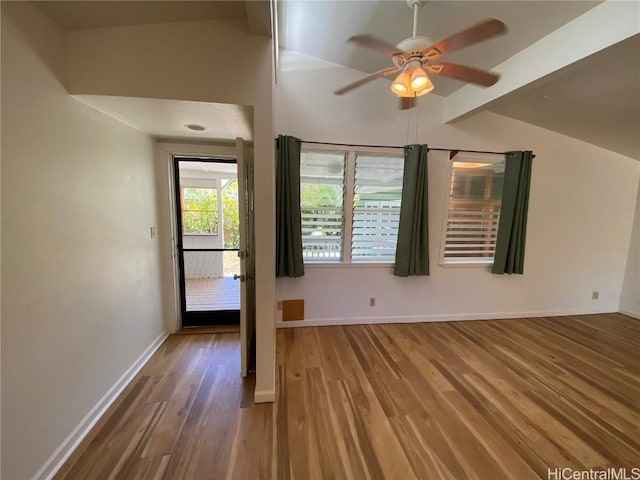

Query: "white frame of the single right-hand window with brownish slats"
left=438, top=152, right=506, bottom=268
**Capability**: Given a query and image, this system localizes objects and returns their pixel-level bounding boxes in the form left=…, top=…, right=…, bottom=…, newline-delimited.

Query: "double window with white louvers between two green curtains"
left=300, top=149, right=404, bottom=263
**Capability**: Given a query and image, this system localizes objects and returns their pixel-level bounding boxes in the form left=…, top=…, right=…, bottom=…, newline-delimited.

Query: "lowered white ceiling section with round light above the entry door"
left=75, top=95, right=253, bottom=141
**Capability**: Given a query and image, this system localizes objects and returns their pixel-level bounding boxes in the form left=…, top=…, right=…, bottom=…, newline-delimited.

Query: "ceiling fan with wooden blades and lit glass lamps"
left=334, top=0, right=507, bottom=109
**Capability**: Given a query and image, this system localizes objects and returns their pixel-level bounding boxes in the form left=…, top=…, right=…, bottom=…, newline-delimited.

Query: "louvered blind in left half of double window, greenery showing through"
left=300, top=151, right=345, bottom=262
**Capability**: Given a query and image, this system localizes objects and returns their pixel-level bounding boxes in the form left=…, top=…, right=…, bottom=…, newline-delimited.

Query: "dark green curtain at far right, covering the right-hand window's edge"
left=491, top=151, right=533, bottom=274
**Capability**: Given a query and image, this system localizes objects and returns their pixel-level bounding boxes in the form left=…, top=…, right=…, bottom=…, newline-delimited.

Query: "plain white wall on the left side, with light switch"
left=2, top=2, right=164, bottom=480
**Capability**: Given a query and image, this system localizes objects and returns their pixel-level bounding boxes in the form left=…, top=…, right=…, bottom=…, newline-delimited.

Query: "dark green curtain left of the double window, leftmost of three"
left=276, top=135, right=304, bottom=277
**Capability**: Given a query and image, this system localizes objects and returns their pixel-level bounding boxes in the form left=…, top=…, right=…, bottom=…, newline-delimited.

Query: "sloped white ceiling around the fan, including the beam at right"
left=279, top=0, right=640, bottom=160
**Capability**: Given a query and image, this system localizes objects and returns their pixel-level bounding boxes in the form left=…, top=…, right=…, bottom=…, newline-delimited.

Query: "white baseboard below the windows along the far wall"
left=276, top=308, right=624, bottom=328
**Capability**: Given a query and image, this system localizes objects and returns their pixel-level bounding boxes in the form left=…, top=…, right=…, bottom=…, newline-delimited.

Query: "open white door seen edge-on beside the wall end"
left=236, top=138, right=256, bottom=377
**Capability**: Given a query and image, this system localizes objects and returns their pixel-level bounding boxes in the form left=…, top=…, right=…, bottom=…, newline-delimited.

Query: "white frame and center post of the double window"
left=300, top=142, right=404, bottom=268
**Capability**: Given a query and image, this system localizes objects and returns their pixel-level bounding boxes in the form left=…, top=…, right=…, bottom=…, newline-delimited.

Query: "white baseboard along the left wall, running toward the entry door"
left=32, top=332, right=169, bottom=480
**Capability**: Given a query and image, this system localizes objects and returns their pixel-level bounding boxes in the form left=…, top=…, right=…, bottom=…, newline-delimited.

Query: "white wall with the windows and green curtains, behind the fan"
left=276, top=52, right=640, bottom=325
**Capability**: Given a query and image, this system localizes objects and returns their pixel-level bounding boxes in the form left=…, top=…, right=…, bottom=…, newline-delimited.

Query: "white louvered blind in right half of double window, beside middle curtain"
left=351, top=155, right=404, bottom=263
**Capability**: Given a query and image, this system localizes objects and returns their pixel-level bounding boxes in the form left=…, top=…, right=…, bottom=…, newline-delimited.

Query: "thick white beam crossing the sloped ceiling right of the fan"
left=445, top=0, right=640, bottom=123
